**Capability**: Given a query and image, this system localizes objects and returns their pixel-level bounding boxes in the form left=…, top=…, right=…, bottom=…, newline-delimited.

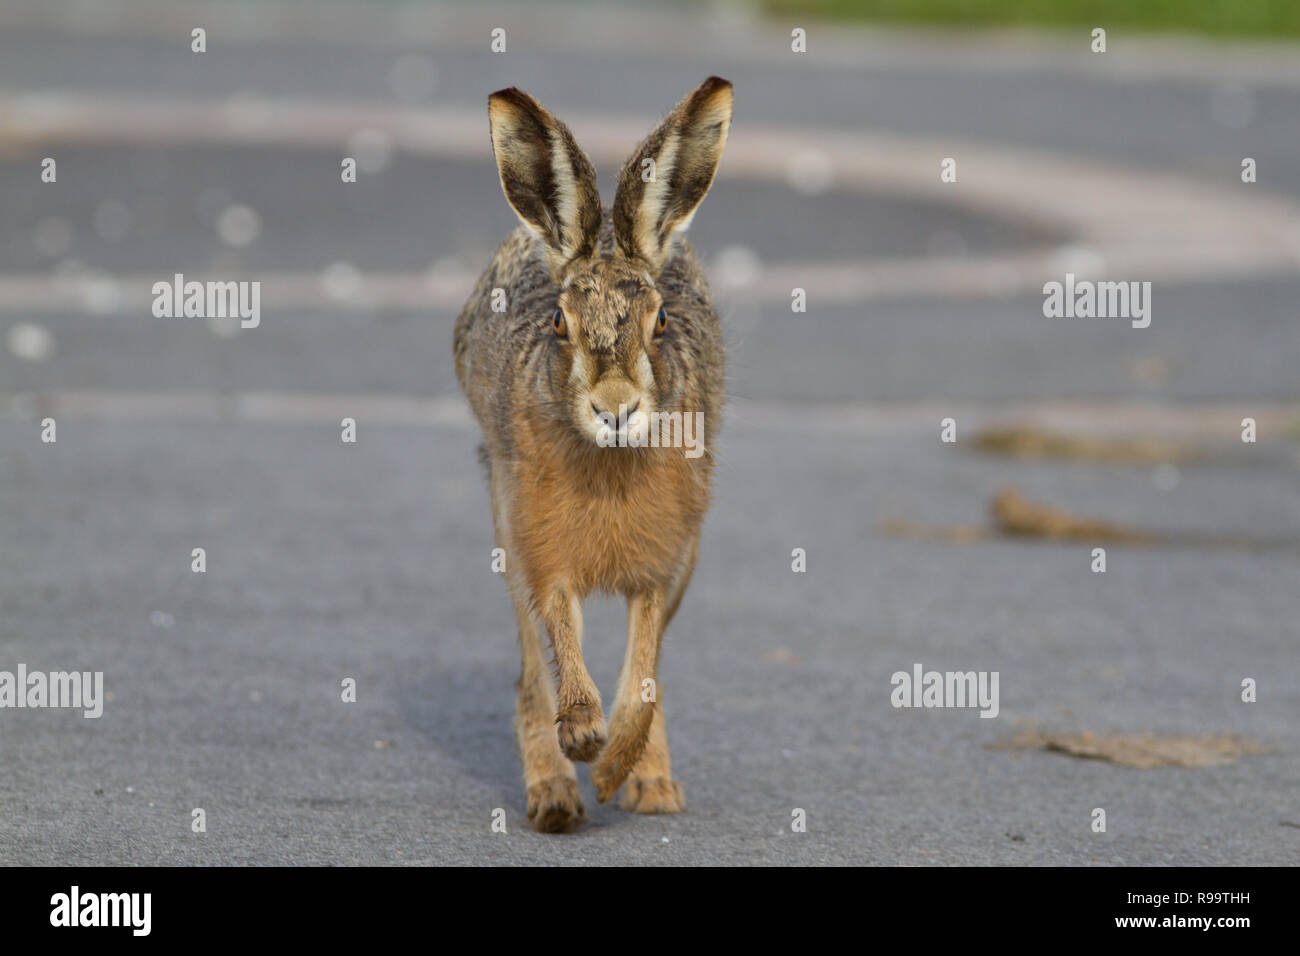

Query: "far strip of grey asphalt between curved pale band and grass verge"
left=0, top=20, right=1300, bottom=195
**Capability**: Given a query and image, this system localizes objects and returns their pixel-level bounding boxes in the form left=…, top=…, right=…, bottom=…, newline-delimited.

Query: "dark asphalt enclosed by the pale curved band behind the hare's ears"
left=0, top=145, right=1062, bottom=273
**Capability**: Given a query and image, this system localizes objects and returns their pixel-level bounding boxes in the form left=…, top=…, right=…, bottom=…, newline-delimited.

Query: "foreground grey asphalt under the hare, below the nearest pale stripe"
left=0, top=423, right=1300, bottom=865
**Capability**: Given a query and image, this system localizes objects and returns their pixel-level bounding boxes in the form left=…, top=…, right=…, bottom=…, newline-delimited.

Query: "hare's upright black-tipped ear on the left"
left=488, top=87, right=601, bottom=280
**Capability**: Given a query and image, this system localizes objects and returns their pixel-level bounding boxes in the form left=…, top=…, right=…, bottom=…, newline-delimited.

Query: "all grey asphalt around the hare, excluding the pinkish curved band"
left=0, top=1, right=1300, bottom=866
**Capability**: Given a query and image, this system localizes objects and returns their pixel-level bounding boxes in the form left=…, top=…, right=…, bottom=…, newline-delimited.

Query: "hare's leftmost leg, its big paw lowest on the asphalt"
left=515, top=602, right=586, bottom=834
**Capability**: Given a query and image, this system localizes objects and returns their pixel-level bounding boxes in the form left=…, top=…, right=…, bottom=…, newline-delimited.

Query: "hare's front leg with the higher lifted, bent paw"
left=542, top=588, right=606, bottom=761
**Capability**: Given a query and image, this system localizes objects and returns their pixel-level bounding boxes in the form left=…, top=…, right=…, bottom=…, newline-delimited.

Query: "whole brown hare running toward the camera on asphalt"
left=455, top=77, right=732, bottom=832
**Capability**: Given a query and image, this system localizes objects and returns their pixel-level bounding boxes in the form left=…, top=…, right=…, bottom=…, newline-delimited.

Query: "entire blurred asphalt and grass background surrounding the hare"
left=0, top=0, right=1300, bottom=864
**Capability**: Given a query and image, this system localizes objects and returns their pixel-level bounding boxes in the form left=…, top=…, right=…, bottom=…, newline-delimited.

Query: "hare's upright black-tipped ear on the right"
left=614, top=77, right=732, bottom=276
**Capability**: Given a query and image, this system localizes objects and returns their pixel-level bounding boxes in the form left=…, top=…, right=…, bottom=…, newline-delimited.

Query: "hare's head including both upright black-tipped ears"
left=489, top=77, right=732, bottom=445
